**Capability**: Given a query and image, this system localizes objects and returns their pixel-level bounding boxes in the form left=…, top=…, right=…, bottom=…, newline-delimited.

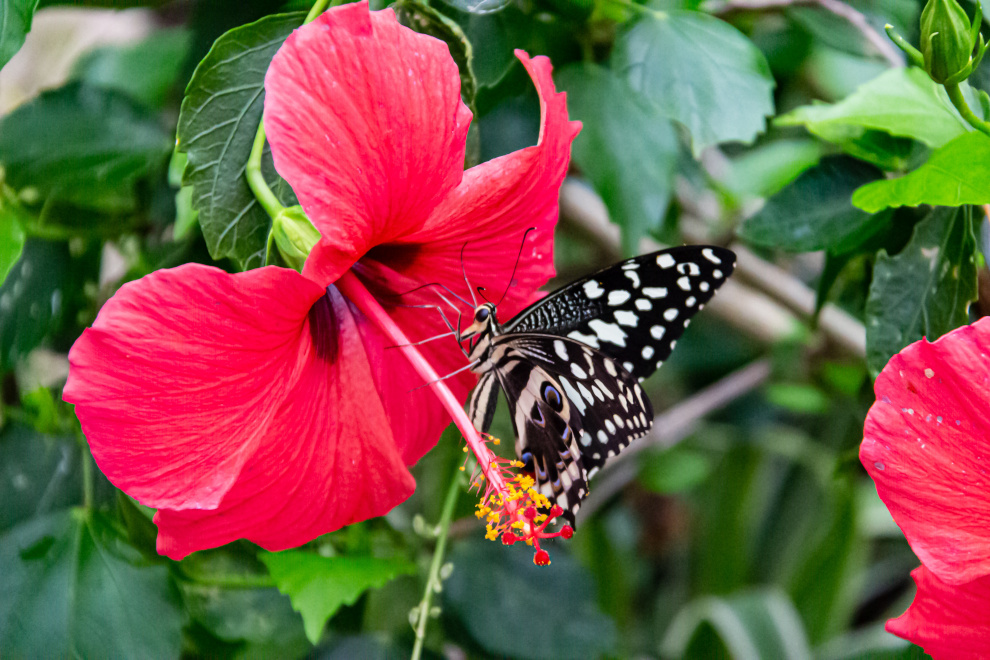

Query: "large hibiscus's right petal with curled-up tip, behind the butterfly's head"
left=322, top=51, right=581, bottom=464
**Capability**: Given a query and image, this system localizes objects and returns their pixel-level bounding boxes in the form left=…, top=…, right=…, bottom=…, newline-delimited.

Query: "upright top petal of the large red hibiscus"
left=265, top=2, right=471, bottom=283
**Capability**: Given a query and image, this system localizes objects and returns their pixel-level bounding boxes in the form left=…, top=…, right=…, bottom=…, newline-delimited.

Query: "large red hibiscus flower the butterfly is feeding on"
left=64, top=3, right=580, bottom=558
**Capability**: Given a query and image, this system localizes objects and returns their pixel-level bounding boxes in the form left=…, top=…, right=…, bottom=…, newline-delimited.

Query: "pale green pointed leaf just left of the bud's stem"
left=775, top=68, right=969, bottom=147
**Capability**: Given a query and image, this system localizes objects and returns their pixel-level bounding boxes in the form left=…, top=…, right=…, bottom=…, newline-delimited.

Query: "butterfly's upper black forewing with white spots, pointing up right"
left=504, top=246, right=736, bottom=380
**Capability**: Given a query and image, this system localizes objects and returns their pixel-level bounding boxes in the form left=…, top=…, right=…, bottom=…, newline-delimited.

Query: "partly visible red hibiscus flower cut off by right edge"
left=859, top=318, right=990, bottom=658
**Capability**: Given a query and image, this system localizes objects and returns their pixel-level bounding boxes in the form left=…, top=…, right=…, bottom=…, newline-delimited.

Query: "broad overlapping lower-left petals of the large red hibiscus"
left=63, top=264, right=414, bottom=559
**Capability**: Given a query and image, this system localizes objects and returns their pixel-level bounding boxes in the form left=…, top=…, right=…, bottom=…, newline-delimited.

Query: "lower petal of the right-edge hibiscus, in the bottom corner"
left=887, top=566, right=990, bottom=660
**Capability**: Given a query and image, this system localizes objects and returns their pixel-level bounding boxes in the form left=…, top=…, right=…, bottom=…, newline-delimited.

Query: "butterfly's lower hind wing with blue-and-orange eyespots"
left=486, top=333, right=653, bottom=525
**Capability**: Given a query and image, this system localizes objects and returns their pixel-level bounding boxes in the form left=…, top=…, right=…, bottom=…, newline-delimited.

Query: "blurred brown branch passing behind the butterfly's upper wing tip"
left=560, top=180, right=866, bottom=357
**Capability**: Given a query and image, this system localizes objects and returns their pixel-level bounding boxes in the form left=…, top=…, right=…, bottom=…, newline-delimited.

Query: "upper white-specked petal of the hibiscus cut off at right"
left=859, top=319, right=990, bottom=584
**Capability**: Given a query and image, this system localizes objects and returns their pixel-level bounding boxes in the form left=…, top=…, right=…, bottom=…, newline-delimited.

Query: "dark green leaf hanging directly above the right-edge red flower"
left=866, top=207, right=977, bottom=374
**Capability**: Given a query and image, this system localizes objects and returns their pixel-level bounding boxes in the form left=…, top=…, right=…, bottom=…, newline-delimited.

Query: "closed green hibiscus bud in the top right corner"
left=921, top=0, right=984, bottom=83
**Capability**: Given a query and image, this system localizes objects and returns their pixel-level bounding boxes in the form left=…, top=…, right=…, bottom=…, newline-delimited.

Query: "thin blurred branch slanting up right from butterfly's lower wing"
left=578, top=359, right=770, bottom=523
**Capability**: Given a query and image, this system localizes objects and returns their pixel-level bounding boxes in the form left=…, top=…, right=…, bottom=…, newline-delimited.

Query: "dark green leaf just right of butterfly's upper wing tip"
left=739, top=156, right=883, bottom=252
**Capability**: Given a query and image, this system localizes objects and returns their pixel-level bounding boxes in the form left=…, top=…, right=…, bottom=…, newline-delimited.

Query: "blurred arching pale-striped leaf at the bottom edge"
left=661, top=590, right=812, bottom=660
